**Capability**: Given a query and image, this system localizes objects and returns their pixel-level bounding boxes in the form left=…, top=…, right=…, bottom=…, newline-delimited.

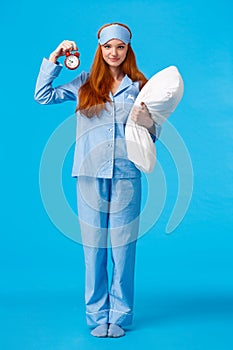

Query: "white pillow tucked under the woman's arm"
left=125, top=66, right=184, bottom=172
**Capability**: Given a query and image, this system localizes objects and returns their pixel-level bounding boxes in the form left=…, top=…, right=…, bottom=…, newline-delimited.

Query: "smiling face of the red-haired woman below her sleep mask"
left=101, top=39, right=128, bottom=67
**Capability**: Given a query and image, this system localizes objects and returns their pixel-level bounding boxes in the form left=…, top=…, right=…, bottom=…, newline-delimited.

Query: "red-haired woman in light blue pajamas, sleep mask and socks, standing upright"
left=35, top=23, right=160, bottom=337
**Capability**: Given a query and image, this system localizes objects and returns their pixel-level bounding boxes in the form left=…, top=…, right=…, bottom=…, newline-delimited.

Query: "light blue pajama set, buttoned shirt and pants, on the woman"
left=35, top=58, right=159, bottom=327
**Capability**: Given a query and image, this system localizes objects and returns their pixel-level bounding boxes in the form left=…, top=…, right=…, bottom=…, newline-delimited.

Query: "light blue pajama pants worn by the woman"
left=77, top=176, right=141, bottom=326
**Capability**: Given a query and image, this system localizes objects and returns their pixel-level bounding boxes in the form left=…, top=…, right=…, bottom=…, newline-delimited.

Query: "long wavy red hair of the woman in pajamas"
left=76, top=22, right=147, bottom=118
